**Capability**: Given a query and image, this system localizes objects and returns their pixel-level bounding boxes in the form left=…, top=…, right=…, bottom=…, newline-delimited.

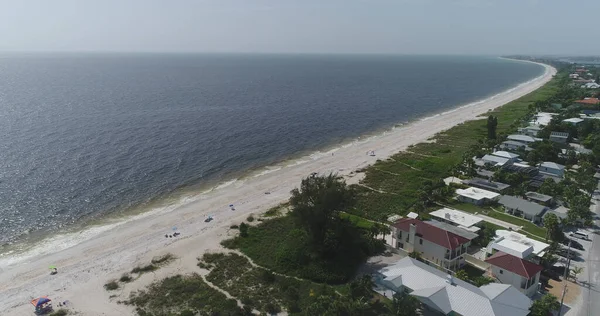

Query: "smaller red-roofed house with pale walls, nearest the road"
left=485, top=251, right=544, bottom=297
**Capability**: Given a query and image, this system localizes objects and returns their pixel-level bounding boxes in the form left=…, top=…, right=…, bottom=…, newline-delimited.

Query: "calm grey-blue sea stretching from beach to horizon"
left=0, top=54, right=543, bottom=244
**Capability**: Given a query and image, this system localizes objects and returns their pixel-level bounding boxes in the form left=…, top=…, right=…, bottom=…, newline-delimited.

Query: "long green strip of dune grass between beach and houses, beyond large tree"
left=352, top=80, right=558, bottom=221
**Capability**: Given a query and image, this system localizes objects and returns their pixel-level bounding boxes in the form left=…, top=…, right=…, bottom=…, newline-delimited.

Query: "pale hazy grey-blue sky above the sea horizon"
left=0, top=0, right=600, bottom=54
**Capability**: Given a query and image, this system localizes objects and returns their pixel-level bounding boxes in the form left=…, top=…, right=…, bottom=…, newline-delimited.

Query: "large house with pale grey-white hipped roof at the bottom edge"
left=374, top=257, right=531, bottom=316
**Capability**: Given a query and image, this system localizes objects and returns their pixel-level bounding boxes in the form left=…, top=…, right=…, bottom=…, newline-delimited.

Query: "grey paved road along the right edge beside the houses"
left=576, top=185, right=600, bottom=316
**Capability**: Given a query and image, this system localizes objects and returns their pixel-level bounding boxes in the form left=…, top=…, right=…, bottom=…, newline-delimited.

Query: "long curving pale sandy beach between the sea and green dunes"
left=0, top=60, right=556, bottom=316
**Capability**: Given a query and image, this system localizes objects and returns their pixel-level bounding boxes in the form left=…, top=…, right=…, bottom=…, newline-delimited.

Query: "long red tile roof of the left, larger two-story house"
left=393, top=218, right=469, bottom=249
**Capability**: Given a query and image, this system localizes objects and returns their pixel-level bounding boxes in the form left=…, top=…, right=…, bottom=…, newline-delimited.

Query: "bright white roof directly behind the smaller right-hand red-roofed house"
left=487, top=230, right=550, bottom=259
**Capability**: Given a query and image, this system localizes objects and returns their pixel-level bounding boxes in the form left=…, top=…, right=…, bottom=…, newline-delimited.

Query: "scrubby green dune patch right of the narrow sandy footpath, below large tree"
left=200, top=253, right=333, bottom=314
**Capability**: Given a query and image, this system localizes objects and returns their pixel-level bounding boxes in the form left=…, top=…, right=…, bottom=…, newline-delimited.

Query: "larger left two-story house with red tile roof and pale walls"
left=392, top=218, right=471, bottom=270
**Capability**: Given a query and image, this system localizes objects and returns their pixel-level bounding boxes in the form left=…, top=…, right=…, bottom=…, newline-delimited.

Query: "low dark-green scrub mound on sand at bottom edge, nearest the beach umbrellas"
left=125, top=274, right=240, bottom=316
